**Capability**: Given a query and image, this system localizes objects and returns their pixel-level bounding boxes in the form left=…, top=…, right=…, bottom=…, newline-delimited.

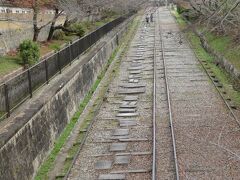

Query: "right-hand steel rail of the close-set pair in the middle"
left=158, top=11, right=180, bottom=180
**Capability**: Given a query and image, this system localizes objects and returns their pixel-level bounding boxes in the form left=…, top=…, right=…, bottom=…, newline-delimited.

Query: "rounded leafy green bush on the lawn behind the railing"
left=19, top=40, right=40, bottom=67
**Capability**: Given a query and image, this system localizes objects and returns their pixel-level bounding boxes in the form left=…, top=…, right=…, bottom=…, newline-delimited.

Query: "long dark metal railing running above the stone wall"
left=0, top=13, right=132, bottom=120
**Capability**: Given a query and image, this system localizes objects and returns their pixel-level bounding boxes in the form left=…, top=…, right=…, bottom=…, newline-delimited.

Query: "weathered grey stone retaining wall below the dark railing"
left=0, top=16, right=132, bottom=180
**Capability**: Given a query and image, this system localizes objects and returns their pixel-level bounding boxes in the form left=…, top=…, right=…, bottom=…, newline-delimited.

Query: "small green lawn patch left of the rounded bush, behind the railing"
left=0, top=56, right=21, bottom=76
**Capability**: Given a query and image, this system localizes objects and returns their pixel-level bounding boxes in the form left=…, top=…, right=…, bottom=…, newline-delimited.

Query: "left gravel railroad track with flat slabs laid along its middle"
left=65, top=10, right=157, bottom=179
